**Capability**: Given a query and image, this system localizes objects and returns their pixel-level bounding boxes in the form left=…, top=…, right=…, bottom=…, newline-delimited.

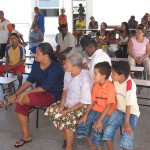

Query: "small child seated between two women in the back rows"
left=107, top=32, right=119, bottom=57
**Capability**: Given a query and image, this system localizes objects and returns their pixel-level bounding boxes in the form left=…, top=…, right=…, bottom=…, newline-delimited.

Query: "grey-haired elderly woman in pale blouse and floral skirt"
left=45, top=53, right=92, bottom=150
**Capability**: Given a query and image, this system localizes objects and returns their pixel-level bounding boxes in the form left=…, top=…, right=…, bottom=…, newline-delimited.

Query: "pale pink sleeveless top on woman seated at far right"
left=131, top=37, right=149, bottom=57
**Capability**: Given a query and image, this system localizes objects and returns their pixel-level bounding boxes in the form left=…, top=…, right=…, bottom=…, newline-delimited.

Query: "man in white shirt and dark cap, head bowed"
left=80, top=35, right=111, bottom=77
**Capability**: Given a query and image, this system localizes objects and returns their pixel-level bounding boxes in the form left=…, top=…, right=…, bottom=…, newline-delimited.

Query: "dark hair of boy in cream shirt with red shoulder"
left=112, top=61, right=130, bottom=78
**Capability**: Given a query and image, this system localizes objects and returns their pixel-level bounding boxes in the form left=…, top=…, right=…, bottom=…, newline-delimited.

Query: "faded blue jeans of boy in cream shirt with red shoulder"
left=103, top=110, right=138, bottom=149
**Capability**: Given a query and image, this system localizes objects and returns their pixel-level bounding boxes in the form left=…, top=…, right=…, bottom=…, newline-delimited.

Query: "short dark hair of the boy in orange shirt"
left=94, top=61, right=111, bottom=79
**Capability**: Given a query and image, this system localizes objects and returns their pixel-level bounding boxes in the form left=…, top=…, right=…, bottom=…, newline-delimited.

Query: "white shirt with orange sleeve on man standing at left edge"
left=0, top=20, right=13, bottom=44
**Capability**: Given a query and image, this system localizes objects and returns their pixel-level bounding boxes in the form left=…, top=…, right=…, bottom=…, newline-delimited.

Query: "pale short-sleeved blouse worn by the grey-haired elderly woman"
left=64, top=69, right=92, bottom=107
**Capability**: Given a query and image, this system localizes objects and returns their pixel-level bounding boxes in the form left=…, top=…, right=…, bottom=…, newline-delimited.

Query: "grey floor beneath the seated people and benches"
left=0, top=37, right=150, bottom=150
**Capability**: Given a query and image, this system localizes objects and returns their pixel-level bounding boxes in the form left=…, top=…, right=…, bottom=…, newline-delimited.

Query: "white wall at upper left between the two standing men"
left=0, top=0, right=32, bottom=41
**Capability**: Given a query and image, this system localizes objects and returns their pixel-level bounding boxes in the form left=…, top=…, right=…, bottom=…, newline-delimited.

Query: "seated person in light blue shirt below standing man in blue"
left=29, top=24, right=44, bottom=54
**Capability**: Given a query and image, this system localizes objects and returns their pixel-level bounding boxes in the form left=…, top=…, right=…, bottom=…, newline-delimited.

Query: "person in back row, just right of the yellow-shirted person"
left=89, top=16, right=98, bottom=36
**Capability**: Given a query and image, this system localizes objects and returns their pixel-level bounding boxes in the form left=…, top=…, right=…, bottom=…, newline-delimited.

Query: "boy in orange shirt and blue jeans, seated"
left=77, top=62, right=116, bottom=150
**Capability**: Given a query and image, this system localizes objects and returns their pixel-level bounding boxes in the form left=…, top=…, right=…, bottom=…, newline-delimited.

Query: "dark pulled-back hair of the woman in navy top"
left=38, top=42, right=57, bottom=60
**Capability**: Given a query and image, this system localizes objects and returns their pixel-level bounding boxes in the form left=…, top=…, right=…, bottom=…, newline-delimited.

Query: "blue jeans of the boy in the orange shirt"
left=77, top=110, right=110, bottom=146
